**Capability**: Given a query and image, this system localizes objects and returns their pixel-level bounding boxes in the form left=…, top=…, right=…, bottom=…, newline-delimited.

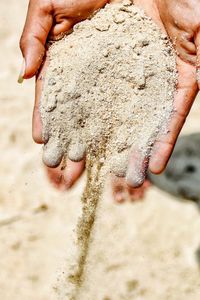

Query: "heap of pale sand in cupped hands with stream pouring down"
left=41, top=1, right=176, bottom=299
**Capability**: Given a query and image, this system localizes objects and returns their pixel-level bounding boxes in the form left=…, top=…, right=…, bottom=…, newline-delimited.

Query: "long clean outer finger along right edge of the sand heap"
left=149, top=58, right=197, bottom=174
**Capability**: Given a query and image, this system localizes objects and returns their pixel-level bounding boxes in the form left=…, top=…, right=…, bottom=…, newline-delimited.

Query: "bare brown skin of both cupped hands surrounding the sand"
left=20, top=0, right=200, bottom=202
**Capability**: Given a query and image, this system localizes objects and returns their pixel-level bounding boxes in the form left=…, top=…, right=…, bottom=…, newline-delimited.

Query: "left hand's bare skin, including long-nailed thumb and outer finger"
left=19, top=0, right=115, bottom=190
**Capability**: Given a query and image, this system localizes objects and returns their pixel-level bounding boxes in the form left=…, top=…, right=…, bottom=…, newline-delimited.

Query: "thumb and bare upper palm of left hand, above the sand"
left=20, top=0, right=109, bottom=80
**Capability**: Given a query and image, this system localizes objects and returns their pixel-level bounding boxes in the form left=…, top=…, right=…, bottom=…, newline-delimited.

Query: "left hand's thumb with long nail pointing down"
left=18, top=0, right=53, bottom=82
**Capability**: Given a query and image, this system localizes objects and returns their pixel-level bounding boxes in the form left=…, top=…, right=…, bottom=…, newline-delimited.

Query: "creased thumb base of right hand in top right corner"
left=156, top=0, right=200, bottom=65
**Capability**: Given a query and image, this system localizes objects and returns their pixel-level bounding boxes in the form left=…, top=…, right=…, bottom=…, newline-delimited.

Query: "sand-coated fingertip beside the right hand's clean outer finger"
left=126, top=149, right=149, bottom=188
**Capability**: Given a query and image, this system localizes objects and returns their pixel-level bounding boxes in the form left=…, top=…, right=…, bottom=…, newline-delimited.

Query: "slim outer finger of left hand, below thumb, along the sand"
left=32, top=57, right=48, bottom=144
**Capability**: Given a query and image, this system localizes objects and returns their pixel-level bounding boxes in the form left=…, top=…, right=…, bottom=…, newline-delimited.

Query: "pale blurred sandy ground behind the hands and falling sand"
left=0, top=0, right=200, bottom=300
